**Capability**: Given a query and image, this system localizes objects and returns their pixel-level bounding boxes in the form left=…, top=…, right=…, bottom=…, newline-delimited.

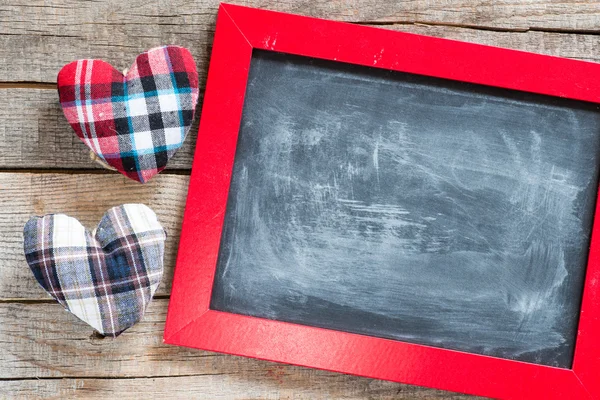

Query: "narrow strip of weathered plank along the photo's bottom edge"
left=0, top=376, right=477, bottom=400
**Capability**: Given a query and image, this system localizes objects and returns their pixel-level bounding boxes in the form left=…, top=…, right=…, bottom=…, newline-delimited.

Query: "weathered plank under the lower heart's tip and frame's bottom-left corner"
left=0, top=299, right=245, bottom=380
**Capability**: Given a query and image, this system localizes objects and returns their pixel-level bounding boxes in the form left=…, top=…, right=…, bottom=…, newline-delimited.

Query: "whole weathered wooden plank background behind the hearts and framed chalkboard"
left=0, top=0, right=600, bottom=399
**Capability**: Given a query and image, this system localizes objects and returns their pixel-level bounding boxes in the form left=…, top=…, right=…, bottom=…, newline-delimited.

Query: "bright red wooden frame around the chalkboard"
left=164, top=4, right=600, bottom=399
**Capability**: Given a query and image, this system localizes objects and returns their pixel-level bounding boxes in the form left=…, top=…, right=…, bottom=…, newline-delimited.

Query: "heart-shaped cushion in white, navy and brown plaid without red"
left=23, top=204, right=166, bottom=337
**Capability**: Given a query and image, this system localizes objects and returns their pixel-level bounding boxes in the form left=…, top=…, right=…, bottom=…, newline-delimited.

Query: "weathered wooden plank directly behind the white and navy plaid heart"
left=0, top=173, right=189, bottom=299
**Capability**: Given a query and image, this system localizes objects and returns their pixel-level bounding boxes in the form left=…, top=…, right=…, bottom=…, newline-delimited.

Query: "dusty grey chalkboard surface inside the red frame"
left=210, top=51, right=600, bottom=368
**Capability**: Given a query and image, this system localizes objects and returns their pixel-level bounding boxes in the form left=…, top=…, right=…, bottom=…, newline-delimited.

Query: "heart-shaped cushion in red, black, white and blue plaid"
left=58, top=46, right=198, bottom=183
